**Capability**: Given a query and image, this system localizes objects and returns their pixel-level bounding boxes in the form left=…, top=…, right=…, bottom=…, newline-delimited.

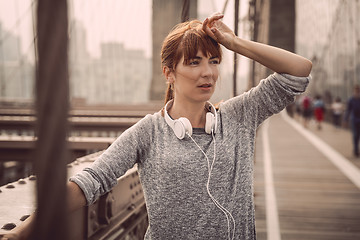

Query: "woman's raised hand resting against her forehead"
left=202, top=13, right=236, bottom=49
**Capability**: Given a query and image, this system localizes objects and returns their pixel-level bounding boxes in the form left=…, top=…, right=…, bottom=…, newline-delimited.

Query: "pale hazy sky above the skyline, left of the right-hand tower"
left=0, top=0, right=253, bottom=99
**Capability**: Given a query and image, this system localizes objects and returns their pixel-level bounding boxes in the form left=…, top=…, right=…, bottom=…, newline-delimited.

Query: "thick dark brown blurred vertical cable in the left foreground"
left=30, top=0, right=69, bottom=240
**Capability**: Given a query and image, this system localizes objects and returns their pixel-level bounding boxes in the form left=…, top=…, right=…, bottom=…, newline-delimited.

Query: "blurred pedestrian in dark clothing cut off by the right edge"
left=345, top=85, right=360, bottom=157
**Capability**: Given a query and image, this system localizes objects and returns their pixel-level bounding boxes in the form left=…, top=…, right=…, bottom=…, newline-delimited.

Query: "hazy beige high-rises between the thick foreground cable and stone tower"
left=69, top=21, right=151, bottom=105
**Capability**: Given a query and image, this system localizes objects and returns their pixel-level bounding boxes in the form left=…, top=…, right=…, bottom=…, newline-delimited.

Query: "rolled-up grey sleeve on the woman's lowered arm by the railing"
left=70, top=114, right=151, bottom=204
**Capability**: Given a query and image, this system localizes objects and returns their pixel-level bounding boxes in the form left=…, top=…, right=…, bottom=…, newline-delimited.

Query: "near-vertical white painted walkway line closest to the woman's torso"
left=262, top=119, right=281, bottom=240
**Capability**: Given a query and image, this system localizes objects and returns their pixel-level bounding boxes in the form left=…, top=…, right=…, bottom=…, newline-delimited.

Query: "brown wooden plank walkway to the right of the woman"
left=254, top=112, right=360, bottom=240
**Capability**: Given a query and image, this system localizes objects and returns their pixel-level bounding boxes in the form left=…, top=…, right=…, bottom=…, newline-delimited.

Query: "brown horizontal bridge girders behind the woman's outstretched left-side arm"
left=0, top=102, right=162, bottom=185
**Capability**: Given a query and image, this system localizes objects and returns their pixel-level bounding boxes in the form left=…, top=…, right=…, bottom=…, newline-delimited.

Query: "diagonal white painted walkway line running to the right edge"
left=281, top=110, right=360, bottom=189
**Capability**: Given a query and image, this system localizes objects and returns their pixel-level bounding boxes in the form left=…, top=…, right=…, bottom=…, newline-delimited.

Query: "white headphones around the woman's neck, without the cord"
left=164, top=99, right=217, bottom=139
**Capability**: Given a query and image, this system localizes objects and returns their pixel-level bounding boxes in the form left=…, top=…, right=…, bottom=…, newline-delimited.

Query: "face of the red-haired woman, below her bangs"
left=171, top=51, right=219, bottom=102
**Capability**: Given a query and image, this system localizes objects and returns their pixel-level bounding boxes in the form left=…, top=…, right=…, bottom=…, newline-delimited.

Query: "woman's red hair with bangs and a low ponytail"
left=161, top=20, right=222, bottom=103
